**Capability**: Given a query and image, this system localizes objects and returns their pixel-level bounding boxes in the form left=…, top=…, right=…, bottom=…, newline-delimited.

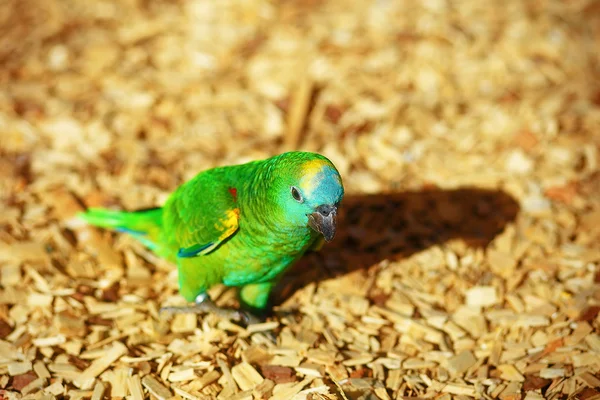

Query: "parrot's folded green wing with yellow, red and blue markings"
left=166, top=175, right=240, bottom=258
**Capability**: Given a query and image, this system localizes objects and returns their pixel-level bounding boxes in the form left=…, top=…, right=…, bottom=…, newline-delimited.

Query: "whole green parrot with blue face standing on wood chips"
left=80, top=151, right=344, bottom=319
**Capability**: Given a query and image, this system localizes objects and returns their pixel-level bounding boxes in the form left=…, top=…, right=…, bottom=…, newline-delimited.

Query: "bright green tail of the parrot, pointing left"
left=79, top=207, right=162, bottom=249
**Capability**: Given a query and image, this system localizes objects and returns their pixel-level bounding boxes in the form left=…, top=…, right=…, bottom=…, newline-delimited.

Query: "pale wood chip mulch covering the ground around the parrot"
left=0, top=0, right=600, bottom=400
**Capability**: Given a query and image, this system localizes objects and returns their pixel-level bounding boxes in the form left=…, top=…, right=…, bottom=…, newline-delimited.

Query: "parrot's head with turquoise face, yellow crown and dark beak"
left=274, top=152, right=344, bottom=242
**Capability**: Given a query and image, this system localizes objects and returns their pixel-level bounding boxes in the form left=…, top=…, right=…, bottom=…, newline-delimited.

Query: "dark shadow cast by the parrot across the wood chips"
left=273, top=187, right=519, bottom=306
